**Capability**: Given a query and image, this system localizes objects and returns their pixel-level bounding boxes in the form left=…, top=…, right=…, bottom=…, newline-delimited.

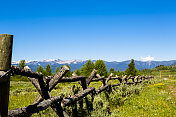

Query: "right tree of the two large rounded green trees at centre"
left=95, top=60, right=107, bottom=77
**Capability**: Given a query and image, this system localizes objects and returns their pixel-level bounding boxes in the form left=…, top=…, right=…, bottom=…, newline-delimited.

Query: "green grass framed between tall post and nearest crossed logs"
left=9, top=81, right=38, bottom=110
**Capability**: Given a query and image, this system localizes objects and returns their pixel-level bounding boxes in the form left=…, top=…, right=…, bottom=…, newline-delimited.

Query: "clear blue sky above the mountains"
left=0, top=0, right=176, bottom=61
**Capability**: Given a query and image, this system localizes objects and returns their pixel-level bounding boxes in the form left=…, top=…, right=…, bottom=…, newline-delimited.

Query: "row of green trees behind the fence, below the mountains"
left=19, top=59, right=140, bottom=77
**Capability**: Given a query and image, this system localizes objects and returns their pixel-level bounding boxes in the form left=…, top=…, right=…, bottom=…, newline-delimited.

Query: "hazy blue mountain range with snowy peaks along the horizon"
left=12, top=59, right=176, bottom=73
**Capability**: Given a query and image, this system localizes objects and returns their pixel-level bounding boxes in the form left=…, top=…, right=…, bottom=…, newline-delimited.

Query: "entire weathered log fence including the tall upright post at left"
left=0, top=35, right=153, bottom=117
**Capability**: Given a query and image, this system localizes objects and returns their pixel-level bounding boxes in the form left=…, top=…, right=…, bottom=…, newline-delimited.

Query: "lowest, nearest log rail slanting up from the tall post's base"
left=8, top=96, right=63, bottom=117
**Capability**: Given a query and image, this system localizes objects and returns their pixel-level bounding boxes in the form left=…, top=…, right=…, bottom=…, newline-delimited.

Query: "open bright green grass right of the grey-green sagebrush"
left=111, top=78, right=176, bottom=117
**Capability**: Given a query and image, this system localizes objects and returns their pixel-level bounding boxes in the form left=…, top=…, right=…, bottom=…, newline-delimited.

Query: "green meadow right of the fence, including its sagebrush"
left=91, top=78, right=176, bottom=117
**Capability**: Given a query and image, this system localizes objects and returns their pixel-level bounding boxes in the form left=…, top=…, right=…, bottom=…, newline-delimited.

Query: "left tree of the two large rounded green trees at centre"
left=81, top=60, right=94, bottom=77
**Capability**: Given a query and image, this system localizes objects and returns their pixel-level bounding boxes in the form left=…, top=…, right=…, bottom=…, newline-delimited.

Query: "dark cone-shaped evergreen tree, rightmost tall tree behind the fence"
left=125, top=59, right=139, bottom=76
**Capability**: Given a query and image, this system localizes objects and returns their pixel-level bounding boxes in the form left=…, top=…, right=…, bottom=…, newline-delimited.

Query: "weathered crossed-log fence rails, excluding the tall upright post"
left=6, top=66, right=153, bottom=117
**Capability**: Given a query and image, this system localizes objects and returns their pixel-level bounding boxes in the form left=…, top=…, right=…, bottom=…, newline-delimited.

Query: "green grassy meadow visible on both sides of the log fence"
left=9, top=71, right=176, bottom=117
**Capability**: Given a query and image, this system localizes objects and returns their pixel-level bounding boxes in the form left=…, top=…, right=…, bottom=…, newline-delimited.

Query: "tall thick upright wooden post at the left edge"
left=0, top=34, right=13, bottom=117
